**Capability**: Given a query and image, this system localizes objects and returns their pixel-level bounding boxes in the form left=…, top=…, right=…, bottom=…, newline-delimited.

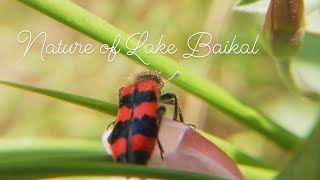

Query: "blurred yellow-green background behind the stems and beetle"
left=0, top=0, right=318, bottom=167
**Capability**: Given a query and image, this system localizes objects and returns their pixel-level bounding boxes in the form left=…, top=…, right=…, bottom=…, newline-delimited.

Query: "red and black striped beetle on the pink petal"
left=108, top=71, right=183, bottom=164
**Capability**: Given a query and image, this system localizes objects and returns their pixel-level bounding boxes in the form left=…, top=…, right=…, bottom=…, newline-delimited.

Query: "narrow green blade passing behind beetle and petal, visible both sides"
left=0, top=81, right=270, bottom=167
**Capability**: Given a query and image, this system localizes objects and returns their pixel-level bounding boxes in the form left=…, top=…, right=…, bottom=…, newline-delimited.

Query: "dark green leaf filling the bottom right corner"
left=277, top=117, right=320, bottom=180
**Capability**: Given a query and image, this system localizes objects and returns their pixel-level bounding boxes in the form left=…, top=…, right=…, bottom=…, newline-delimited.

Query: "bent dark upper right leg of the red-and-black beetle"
left=160, top=93, right=183, bottom=122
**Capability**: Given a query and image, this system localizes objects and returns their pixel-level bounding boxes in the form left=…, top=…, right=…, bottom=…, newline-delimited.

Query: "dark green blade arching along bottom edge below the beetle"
left=0, top=162, right=222, bottom=180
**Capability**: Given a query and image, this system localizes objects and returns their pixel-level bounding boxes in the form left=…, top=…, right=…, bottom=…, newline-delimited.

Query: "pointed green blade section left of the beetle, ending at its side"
left=0, top=81, right=118, bottom=116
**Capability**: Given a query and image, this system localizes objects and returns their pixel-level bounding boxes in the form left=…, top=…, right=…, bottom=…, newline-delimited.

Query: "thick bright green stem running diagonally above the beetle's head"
left=18, top=0, right=300, bottom=149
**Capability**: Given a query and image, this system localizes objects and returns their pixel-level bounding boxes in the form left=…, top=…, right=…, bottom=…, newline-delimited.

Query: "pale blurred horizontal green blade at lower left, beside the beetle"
left=0, top=138, right=112, bottom=166
